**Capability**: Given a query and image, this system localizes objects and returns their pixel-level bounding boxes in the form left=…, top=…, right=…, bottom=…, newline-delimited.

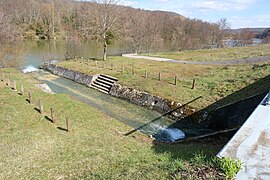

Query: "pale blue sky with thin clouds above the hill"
left=125, top=0, right=270, bottom=29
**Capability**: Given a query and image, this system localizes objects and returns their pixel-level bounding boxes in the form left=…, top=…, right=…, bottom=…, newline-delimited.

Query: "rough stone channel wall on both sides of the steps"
left=41, top=63, right=195, bottom=119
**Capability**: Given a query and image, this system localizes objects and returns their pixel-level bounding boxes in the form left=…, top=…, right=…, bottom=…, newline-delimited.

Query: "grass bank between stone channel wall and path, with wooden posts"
left=59, top=56, right=270, bottom=110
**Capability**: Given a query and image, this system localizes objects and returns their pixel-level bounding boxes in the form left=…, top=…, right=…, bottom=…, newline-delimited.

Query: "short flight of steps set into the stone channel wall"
left=90, top=74, right=118, bottom=94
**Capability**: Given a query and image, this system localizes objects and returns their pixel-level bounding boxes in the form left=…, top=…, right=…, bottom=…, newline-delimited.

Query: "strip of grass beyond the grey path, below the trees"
left=143, top=44, right=270, bottom=61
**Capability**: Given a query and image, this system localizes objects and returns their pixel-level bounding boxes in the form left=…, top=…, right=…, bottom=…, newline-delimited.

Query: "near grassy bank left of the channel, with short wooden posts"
left=0, top=69, right=229, bottom=179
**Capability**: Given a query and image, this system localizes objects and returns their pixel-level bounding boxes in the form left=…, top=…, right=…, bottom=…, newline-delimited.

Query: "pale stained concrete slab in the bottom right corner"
left=217, top=94, right=270, bottom=180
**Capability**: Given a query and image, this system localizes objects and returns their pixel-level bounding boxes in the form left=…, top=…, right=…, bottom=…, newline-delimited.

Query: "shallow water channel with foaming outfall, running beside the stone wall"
left=37, top=71, right=216, bottom=142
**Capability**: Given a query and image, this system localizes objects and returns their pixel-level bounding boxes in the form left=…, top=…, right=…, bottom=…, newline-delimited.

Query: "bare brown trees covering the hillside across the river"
left=0, top=0, right=229, bottom=60
